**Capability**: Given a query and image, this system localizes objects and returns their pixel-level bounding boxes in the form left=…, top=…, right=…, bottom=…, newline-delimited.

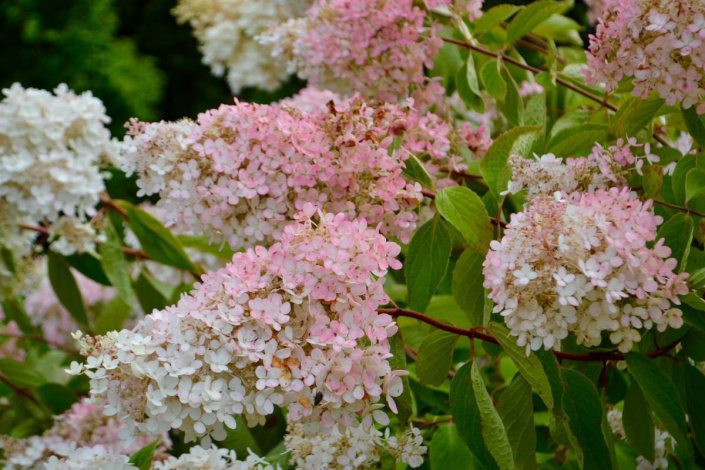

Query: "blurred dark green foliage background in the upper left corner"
left=0, top=0, right=586, bottom=137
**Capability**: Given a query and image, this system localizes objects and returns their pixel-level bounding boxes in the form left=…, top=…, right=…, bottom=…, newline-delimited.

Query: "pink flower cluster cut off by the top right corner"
left=584, top=0, right=705, bottom=114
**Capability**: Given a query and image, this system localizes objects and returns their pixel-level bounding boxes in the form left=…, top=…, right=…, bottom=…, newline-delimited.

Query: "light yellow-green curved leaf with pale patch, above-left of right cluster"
left=480, top=126, right=543, bottom=200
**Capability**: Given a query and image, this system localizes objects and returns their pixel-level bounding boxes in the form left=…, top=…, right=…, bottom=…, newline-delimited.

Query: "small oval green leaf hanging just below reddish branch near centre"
left=416, top=330, right=460, bottom=387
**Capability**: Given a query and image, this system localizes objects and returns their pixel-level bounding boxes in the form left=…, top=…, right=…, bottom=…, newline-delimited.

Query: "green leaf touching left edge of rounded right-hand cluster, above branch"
left=452, top=250, right=485, bottom=326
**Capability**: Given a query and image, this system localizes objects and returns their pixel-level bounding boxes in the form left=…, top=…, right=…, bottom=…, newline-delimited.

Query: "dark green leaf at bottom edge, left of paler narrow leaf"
left=450, top=361, right=498, bottom=470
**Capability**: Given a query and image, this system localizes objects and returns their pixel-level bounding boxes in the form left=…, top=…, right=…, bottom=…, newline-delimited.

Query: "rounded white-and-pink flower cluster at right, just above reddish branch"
left=484, top=188, right=688, bottom=354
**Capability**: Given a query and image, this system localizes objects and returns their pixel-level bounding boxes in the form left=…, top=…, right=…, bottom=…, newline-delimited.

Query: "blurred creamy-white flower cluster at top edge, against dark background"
left=173, top=0, right=311, bottom=94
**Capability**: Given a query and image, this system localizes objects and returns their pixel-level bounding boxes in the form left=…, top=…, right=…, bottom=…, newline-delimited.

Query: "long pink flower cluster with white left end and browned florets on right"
left=123, top=98, right=478, bottom=249
